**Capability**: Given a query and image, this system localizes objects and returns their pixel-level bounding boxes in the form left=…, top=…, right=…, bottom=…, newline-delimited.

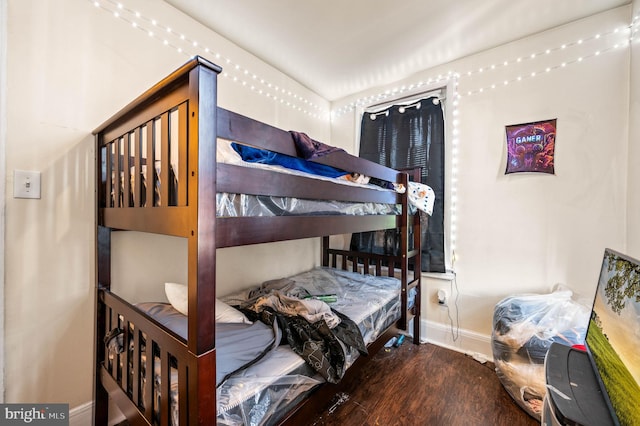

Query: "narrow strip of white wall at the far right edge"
left=627, top=0, right=640, bottom=259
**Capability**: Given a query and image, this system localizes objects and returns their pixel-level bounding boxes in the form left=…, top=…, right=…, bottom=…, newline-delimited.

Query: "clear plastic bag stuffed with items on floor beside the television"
left=491, top=289, right=591, bottom=420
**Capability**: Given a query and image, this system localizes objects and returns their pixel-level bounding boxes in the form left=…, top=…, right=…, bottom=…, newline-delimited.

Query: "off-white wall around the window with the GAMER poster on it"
left=332, top=7, right=637, bottom=355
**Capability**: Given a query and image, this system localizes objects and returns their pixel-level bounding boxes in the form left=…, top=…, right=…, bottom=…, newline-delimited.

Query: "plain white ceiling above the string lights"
left=166, top=0, right=630, bottom=100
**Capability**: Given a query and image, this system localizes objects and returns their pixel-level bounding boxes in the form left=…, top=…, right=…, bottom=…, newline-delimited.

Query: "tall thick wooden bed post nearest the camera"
left=187, top=60, right=221, bottom=425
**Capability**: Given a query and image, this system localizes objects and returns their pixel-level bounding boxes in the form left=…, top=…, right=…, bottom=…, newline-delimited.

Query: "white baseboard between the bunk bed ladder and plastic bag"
left=420, top=319, right=493, bottom=362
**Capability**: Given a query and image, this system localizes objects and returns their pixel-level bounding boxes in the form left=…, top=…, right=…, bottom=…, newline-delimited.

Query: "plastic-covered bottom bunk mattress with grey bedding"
left=138, top=267, right=408, bottom=425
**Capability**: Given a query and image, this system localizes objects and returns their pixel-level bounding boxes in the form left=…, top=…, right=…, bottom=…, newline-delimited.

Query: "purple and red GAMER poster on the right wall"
left=505, top=118, right=556, bottom=174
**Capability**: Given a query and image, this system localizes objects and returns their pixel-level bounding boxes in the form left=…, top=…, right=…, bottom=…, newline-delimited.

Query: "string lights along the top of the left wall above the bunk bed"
left=89, top=0, right=330, bottom=121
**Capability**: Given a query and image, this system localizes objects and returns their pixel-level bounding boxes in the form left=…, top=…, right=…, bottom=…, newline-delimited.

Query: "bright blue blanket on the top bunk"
left=231, top=142, right=348, bottom=178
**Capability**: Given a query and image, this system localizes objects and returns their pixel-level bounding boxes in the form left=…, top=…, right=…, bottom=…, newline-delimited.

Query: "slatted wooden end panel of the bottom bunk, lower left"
left=98, top=291, right=216, bottom=425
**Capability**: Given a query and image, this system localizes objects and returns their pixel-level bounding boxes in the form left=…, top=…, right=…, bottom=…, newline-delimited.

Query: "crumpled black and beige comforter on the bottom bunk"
left=241, top=289, right=367, bottom=383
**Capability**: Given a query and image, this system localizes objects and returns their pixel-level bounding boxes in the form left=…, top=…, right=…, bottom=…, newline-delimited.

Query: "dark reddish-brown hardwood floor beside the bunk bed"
left=312, top=342, right=540, bottom=426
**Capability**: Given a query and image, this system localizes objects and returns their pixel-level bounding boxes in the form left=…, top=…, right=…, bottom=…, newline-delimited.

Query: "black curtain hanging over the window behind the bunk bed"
left=351, top=98, right=445, bottom=272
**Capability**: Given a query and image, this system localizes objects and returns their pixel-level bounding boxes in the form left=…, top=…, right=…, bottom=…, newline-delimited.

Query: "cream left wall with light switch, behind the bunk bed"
left=2, top=0, right=330, bottom=411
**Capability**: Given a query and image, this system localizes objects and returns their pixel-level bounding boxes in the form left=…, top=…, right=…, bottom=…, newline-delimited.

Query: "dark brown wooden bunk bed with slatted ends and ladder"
left=94, top=57, right=420, bottom=425
